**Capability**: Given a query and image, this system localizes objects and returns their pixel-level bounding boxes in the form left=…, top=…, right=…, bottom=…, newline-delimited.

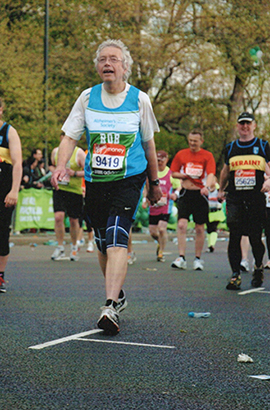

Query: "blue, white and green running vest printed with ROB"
left=85, top=84, right=147, bottom=182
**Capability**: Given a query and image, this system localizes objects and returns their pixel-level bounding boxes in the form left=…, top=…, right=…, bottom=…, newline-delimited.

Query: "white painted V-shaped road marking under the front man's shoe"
left=28, top=329, right=175, bottom=350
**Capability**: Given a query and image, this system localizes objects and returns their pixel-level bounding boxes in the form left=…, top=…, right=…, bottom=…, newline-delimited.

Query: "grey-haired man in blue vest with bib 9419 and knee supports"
left=52, top=40, right=162, bottom=334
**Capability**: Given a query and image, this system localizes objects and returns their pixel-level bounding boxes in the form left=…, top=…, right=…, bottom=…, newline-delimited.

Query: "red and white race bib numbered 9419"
left=92, top=143, right=126, bottom=171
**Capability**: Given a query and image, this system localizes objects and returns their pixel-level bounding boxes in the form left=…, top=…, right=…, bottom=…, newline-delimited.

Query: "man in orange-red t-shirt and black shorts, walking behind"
left=171, top=129, right=216, bottom=270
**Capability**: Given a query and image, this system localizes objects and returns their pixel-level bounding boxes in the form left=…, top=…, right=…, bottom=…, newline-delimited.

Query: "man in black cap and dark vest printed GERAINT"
left=219, top=112, right=270, bottom=290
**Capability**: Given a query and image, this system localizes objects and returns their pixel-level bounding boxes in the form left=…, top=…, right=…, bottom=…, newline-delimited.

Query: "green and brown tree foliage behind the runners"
left=0, top=0, right=270, bottom=173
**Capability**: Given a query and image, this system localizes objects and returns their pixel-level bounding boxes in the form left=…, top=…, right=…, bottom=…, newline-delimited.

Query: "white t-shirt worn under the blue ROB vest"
left=62, top=84, right=159, bottom=141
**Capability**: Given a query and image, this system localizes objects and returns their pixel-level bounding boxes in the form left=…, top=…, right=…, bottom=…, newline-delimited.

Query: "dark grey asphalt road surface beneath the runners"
left=0, top=235, right=270, bottom=410
